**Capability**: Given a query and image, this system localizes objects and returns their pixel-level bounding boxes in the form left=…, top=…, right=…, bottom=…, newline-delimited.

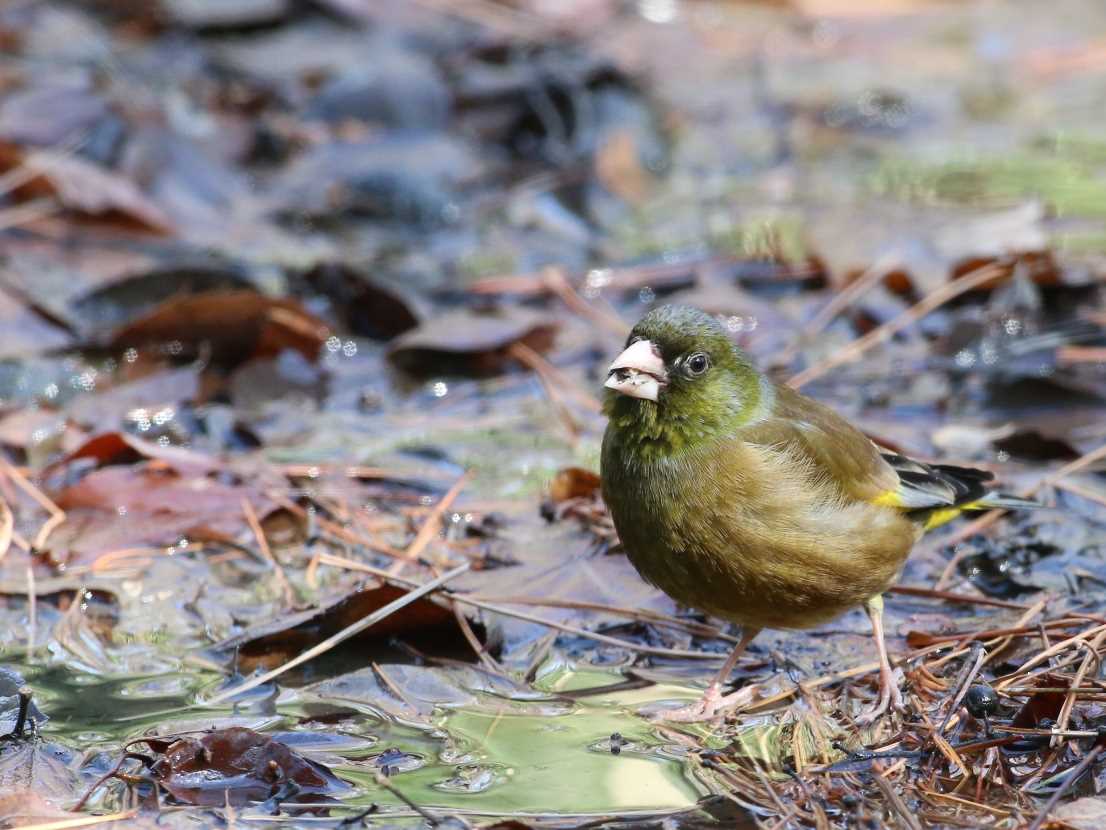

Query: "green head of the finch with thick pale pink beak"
left=604, top=305, right=765, bottom=449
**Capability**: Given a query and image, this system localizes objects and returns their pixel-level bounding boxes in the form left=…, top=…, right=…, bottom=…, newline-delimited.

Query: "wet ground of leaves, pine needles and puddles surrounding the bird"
left=0, top=0, right=1106, bottom=828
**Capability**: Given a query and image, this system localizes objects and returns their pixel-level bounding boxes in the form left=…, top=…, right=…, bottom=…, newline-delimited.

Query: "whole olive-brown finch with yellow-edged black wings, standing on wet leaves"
left=601, top=305, right=1034, bottom=724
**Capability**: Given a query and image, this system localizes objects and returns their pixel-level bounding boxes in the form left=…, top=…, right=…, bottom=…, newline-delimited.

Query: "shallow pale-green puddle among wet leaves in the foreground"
left=23, top=666, right=709, bottom=817
